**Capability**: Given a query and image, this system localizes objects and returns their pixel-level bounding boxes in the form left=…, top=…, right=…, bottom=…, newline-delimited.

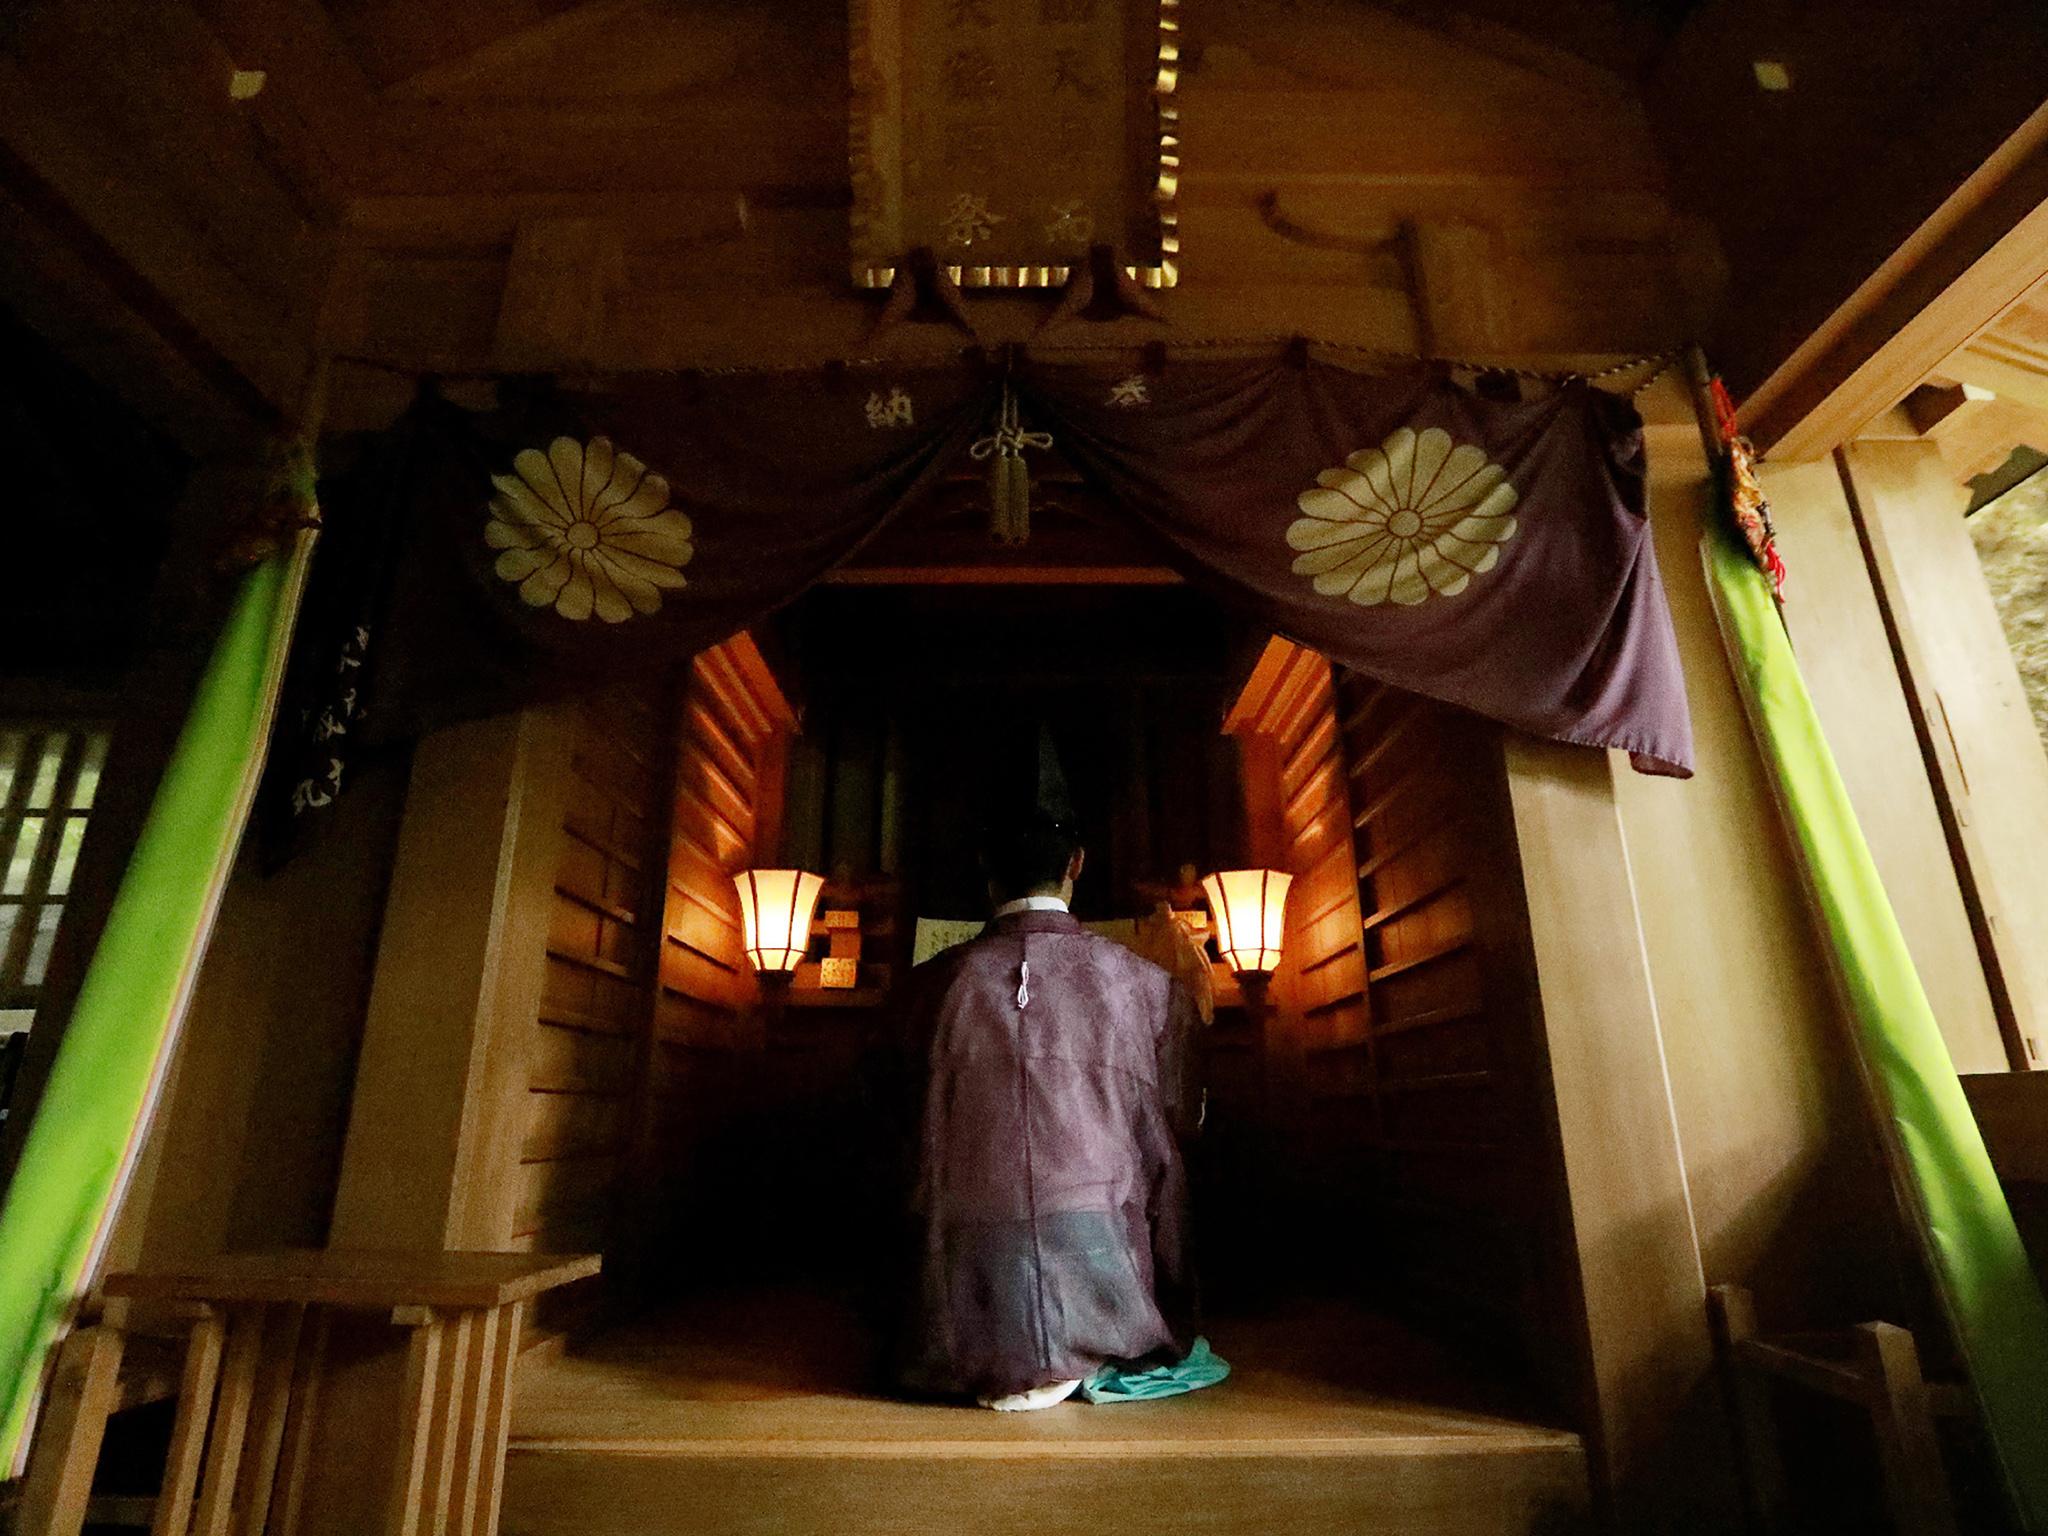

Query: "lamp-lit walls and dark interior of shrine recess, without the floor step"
left=514, top=557, right=1571, bottom=1392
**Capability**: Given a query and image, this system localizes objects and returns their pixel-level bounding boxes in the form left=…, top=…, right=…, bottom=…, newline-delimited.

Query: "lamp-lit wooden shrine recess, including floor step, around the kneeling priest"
left=468, top=565, right=1587, bottom=1532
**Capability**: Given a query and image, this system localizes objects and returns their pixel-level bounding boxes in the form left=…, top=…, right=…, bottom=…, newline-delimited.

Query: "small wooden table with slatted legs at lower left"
left=104, top=1249, right=598, bottom=1536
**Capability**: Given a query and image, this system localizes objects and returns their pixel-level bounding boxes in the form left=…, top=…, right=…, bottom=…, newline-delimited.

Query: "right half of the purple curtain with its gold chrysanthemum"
left=1020, top=358, right=1692, bottom=776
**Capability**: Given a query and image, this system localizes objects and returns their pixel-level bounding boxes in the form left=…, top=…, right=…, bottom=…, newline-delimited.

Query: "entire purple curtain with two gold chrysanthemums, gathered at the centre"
left=272, top=358, right=1692, bottom=848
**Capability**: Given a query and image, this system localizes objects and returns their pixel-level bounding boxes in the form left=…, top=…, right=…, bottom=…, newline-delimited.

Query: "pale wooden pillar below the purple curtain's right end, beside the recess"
left=1505, top=733, right=1733, bottom=1532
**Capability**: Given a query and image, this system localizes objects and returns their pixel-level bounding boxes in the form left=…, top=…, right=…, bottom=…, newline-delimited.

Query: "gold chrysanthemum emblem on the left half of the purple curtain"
left=483, top=436, right=694, bottom=625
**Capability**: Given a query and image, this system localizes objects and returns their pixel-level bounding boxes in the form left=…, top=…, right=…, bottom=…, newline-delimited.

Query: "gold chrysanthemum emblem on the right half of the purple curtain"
left=1286, top=426, right=1516, bottom=606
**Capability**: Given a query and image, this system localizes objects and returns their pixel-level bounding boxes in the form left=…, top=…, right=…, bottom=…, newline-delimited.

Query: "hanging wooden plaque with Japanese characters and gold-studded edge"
left=852, top=0, right=1180, bottom=289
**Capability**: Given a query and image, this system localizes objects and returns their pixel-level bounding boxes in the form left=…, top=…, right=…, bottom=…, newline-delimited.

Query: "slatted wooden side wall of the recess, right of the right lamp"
left=1337, top=676, right=1550, bottom=1368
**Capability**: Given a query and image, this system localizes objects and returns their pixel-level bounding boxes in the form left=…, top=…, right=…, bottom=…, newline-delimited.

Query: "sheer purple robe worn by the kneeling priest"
left=899, top=911, right=1194, bottom=1397
